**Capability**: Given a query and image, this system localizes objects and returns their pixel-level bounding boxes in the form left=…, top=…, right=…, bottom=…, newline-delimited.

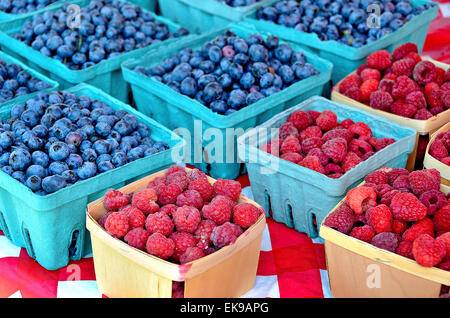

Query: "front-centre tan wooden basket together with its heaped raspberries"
left=87, top=165, right=265, bottom=297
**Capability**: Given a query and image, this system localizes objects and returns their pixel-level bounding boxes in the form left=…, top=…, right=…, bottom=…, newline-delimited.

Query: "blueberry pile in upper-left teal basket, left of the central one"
left=13, top=0, right=189, bottom=70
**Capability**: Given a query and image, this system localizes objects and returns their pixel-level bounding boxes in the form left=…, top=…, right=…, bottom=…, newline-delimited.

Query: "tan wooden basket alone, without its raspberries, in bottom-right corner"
left=320, top=169, right=450, bottom=298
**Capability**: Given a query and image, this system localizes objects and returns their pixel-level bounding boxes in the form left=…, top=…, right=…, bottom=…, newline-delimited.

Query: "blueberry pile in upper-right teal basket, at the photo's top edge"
left=256, top=0, right=435, bottom=47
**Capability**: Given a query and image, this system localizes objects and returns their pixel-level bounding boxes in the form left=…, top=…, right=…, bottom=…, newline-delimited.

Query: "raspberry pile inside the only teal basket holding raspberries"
left=260, top=110, right=395, bottom=179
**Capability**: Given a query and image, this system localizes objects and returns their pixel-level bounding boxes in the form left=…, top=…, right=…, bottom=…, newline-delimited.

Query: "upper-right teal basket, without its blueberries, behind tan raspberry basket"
left=244, top=0, right=438, bottom=86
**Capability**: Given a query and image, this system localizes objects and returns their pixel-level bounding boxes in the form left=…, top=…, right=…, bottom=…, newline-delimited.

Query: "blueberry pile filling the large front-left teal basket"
left=0, top=91, right=169, bottom=195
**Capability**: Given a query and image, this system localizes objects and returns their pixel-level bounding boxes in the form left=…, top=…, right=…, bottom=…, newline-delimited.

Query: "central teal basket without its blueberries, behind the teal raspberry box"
left=122, top=24, right=332, bottom=179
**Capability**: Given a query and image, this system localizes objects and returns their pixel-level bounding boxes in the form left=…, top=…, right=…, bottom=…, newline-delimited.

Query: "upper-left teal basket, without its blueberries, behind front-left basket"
left=0, top=0, right=193, bottom=102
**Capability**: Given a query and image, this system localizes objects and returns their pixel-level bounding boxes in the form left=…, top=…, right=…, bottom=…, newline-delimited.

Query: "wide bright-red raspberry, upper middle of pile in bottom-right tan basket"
left=390, top=193, right=427, bottom=222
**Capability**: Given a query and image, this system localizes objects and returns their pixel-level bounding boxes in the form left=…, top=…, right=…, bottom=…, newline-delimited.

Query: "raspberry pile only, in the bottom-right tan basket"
left=324, top=168, right=450, bottom=271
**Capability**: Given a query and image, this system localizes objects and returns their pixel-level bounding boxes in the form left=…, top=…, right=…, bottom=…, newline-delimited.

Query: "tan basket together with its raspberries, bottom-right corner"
left=320, top=168, right=450, bottom=297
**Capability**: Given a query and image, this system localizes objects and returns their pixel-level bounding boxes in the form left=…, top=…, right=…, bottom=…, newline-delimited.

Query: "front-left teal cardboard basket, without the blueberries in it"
left=0, top=84, right=184, bottom=270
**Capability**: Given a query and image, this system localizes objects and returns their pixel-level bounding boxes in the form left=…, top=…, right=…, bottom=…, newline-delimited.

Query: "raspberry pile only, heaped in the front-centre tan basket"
left=98, top=165, right=264, bottom=264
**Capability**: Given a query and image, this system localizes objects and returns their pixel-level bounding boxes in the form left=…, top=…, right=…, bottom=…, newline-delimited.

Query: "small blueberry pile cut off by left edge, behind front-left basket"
left=0, top=58, right=51, bottom=103
